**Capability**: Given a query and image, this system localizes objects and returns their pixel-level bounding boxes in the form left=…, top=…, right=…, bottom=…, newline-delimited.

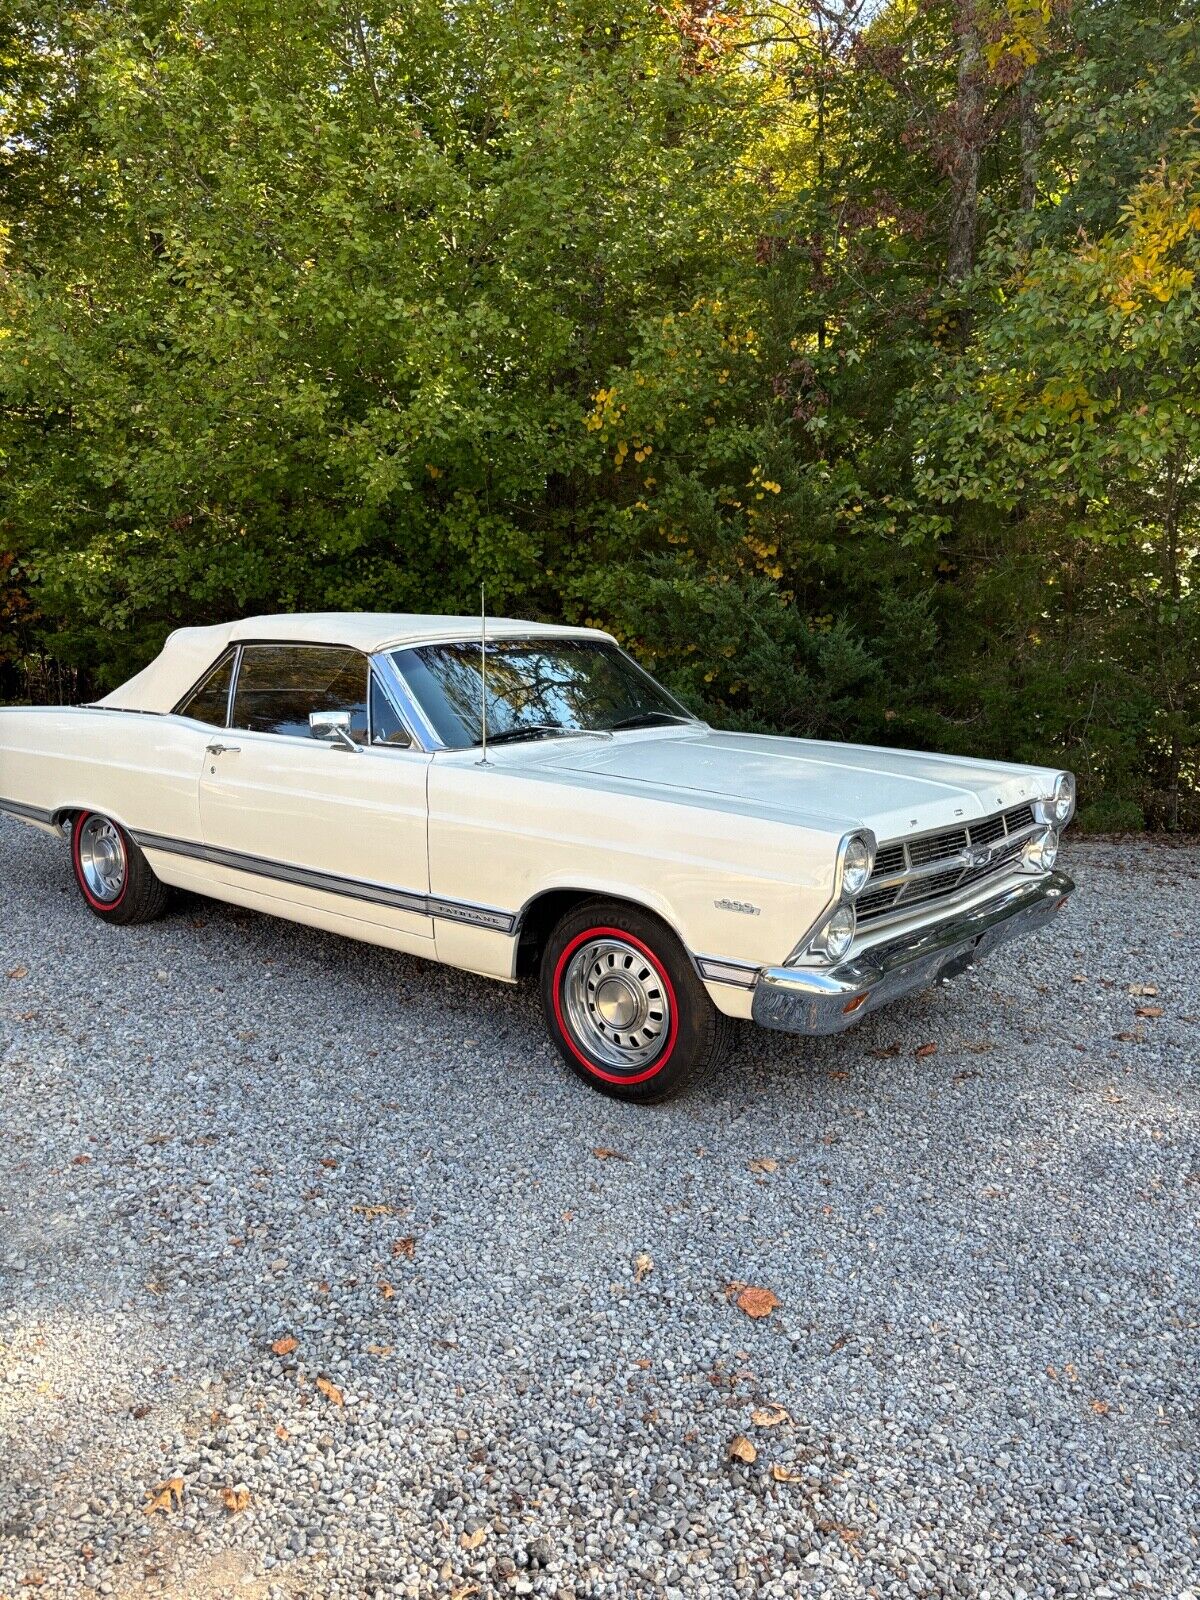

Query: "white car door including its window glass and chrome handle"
left=200, top=643, right=434, bottom=939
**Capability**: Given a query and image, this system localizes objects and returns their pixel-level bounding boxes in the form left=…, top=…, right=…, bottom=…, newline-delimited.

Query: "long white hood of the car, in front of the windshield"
left=538, top=726, right=1053, bottom=838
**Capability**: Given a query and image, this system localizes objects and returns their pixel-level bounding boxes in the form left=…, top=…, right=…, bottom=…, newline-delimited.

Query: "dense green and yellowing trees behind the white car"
left=0, top=0, right=1200, bottom=827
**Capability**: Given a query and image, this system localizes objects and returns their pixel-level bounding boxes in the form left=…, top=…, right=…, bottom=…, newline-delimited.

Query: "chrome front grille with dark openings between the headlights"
left=856, top=805, right=1037, bottom=926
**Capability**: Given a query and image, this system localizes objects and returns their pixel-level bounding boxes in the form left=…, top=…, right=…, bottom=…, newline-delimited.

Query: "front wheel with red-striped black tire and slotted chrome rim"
left=541, top=899, right=726, bottom=1104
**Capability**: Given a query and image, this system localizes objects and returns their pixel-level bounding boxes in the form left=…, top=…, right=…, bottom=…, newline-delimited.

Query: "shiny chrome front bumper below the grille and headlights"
left=750, top=872, right=1075, bottom=1034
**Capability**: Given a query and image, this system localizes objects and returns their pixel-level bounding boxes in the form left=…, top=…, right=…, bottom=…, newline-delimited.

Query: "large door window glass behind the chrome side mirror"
left=230, top=645, right=368, bottom=744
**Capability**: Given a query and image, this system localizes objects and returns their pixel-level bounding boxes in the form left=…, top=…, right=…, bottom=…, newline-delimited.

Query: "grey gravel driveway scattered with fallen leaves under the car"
left=0, top=821, right=1200, bottom=1600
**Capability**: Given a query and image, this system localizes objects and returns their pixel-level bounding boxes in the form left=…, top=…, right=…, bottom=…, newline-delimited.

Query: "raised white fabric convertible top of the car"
left=96, top=611, right=610, bottom=712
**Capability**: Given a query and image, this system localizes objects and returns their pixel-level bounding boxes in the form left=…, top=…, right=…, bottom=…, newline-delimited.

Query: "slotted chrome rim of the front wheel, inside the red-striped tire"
left=563, top=938, right=670, bottom=1072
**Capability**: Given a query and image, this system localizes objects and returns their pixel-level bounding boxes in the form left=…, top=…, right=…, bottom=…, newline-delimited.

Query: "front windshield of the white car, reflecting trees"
left=392, top=638, right=693, bottom=750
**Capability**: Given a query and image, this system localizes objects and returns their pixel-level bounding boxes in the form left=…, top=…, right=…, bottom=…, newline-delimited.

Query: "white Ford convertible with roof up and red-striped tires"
left=0, top=614, right=1075, bottom=1101
